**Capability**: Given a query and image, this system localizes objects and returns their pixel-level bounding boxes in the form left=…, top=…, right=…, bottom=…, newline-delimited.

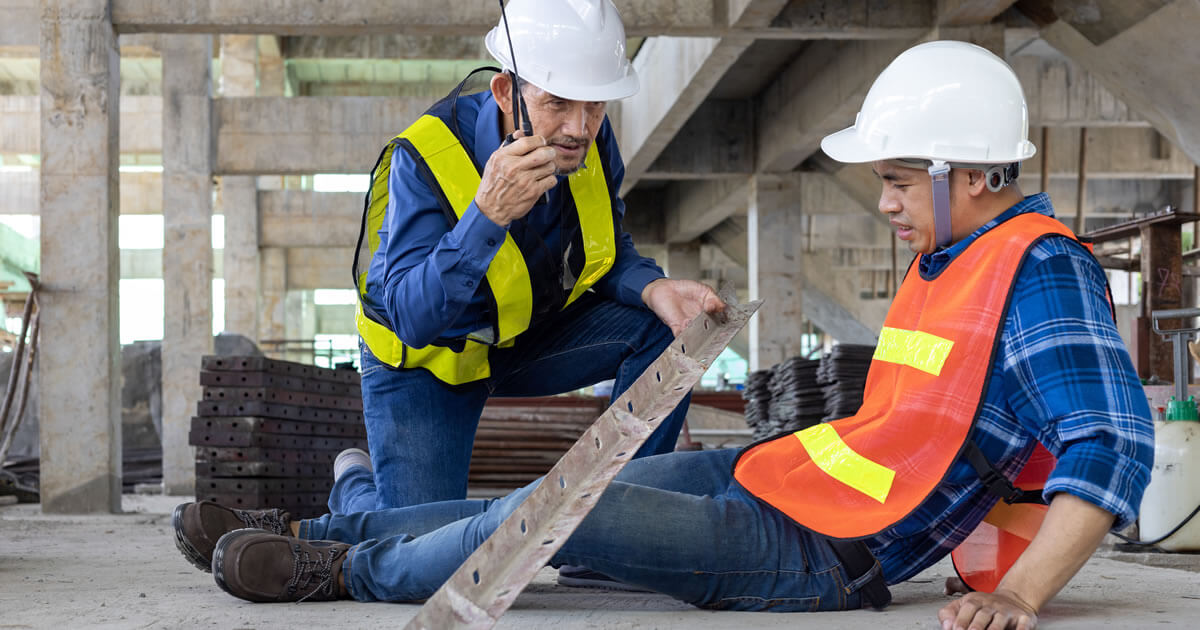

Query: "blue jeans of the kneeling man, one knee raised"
left=329, top=293, right=689, bottom=514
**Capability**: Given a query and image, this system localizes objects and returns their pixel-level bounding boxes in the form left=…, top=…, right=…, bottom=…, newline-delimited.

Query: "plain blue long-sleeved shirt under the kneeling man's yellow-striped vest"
left=366, top=91, right=664, bottom=348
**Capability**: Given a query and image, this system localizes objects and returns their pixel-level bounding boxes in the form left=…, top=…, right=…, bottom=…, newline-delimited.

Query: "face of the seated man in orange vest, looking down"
left=871, top=161, right=937, bottom=253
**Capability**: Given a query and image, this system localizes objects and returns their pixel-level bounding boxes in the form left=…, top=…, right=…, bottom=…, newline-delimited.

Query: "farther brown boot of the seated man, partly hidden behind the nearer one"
left=170, top=500, right=292, bottom=572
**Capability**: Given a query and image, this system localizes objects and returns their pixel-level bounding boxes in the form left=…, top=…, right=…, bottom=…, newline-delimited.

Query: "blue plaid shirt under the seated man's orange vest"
left=866, top=194, right=1154, bottom=584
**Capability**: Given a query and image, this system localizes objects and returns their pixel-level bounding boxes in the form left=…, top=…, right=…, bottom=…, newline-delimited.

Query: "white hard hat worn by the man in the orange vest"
left=821, top=41, right=1036, bottom=164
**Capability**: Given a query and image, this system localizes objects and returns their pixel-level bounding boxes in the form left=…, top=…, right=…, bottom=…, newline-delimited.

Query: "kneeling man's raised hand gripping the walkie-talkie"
left=475, top=131, right=558, bottom=228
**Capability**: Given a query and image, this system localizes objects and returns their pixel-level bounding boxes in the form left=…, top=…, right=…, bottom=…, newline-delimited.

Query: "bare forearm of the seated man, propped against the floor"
left=996, top=493, right=1114, bottom=611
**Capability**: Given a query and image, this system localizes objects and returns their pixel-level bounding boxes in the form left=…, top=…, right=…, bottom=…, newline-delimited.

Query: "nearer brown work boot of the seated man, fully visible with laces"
left=212, top=529, right=350, bottom=602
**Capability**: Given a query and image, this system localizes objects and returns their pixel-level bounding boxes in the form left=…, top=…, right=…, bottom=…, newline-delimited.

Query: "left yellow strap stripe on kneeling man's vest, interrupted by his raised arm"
left=400, top=114, right=533, bottom=343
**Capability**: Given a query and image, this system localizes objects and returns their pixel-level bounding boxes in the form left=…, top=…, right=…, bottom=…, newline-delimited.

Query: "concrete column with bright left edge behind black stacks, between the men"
left=746, top=175, right=804, bottom=370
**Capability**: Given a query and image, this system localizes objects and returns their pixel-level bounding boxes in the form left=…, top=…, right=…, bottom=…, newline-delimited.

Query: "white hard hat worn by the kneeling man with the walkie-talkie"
left=484, top=0, right=637, bottom=101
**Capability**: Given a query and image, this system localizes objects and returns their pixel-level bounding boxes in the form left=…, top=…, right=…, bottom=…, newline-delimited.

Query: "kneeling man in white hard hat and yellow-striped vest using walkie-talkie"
left=329, top=0, right=724, bottom=512
